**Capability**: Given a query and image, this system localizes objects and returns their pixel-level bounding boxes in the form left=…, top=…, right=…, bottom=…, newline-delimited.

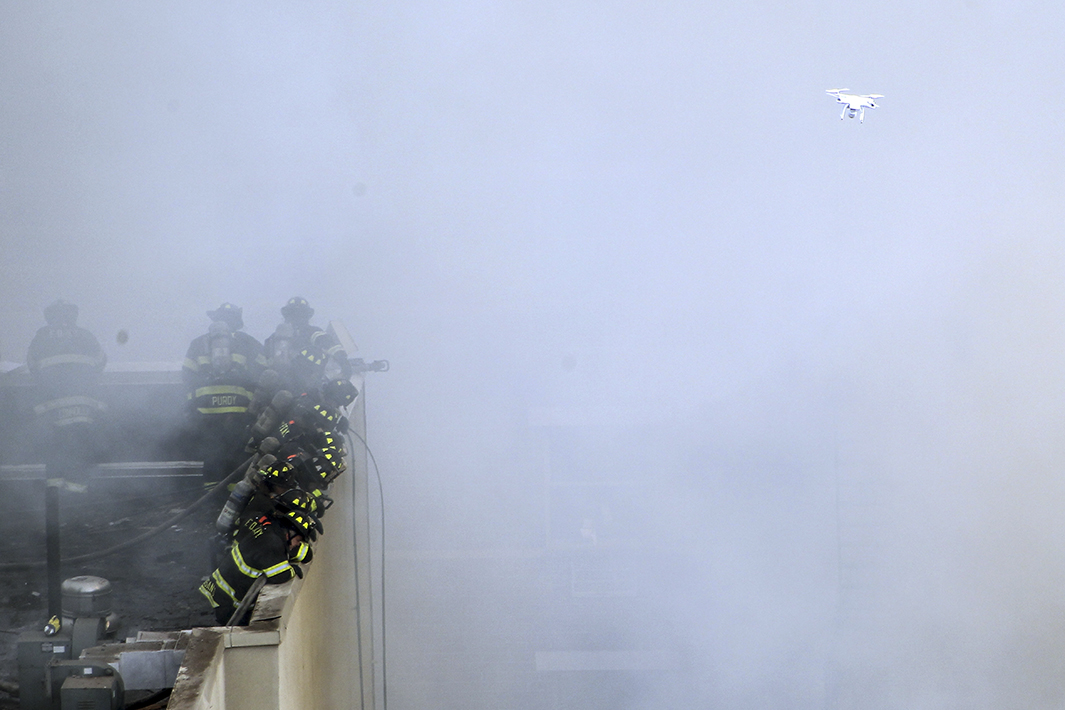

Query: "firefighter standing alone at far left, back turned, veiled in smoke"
left=26, top=299, right=108, bottom=483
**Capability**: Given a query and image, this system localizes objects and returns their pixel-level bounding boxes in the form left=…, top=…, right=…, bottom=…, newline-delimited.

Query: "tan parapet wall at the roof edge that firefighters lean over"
left=167, top=374, right=375, bottom=710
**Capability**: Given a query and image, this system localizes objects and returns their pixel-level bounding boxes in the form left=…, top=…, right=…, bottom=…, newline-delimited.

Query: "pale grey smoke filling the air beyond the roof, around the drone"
left=0, top=0, right=1065, bottom=708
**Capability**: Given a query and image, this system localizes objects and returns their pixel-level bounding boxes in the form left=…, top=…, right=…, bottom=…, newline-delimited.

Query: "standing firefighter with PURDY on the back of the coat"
left=181, top=303, right=266, bottom=486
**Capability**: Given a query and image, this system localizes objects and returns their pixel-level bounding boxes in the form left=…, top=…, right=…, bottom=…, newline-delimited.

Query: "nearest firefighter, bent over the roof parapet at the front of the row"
left=199, top=490, right=322, bottom=625
